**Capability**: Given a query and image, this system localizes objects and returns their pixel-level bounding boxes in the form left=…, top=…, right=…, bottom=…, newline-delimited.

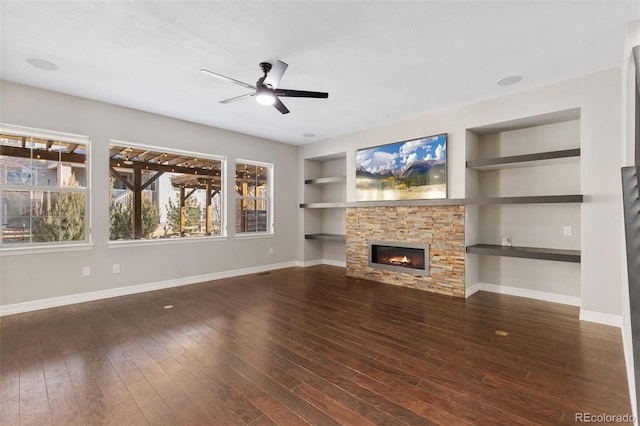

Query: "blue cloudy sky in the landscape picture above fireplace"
left=356, top=134, right=447, bottom=173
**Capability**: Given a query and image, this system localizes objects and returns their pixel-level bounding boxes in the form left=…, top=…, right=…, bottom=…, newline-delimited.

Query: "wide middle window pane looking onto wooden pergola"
left=109, top=142, right=226, bottom=241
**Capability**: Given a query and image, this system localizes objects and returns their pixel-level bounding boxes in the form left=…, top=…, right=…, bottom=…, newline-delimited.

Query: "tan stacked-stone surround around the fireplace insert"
left=347, top=205, right=465, bottom=297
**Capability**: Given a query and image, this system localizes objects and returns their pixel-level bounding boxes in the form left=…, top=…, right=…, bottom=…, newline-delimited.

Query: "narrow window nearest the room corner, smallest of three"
left=236, top=160, right=273, bottom=233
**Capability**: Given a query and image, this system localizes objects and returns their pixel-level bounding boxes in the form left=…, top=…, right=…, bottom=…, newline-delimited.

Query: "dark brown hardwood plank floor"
left=0, top=266, right=630, bottom=426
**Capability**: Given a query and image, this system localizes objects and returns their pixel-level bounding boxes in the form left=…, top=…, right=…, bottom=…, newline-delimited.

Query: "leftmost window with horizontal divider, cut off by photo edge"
left=0, top=125, right=89, bottom=249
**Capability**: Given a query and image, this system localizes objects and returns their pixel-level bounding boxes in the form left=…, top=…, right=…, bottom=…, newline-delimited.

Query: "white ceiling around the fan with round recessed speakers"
left=0, top=0, right=640, bottom=144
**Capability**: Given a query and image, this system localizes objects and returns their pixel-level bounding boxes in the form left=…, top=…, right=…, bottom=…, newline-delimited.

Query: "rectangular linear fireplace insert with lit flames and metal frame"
left=368, top=241, right=429, bottom=276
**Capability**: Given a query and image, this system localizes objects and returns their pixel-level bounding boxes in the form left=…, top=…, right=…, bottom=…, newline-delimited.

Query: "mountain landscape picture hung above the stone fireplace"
left=356, top=133, right=447, bottom=201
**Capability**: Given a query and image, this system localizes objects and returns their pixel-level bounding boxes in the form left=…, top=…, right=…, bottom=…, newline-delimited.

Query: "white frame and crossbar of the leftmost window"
left=0, top=123, right=93, bottom=255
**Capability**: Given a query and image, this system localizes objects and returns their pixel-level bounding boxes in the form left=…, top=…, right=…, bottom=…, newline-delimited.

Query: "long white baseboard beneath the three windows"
left=0, top=262, right=300, bottom=316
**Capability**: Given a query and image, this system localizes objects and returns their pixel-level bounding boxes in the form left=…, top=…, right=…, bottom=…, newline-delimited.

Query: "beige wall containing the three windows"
left=0, top=82, right=299, bottom=306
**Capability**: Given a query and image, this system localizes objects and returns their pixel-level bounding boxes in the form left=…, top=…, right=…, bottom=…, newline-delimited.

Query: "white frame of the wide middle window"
left=106, top=139, right=228, bottom=248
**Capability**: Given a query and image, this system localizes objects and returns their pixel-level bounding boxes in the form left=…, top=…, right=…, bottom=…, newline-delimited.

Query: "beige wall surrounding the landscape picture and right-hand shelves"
left=298, top=69, right=622, bottom=316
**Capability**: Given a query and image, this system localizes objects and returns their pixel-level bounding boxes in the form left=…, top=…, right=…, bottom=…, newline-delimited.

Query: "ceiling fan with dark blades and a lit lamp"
left=200, top=61, right=329, bottom=114
